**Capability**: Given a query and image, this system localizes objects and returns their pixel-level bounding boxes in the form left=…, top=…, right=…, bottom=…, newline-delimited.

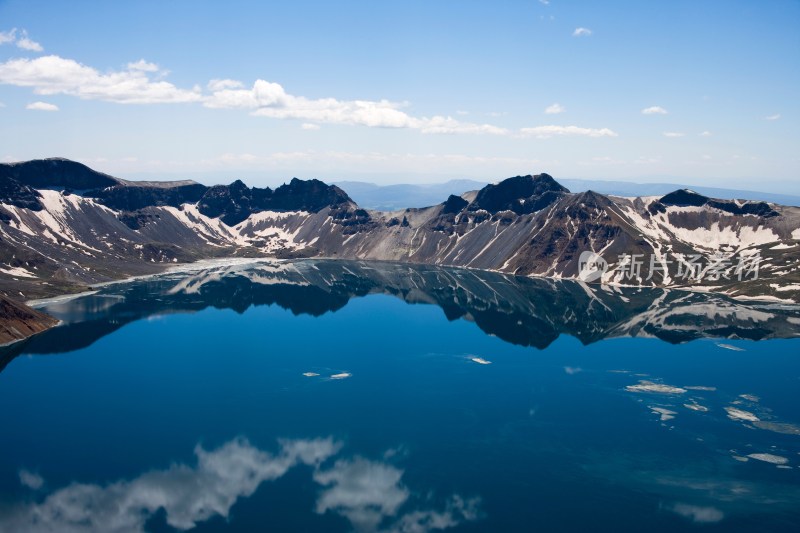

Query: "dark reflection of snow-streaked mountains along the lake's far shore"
left=2, top=260, right=800, bottom=363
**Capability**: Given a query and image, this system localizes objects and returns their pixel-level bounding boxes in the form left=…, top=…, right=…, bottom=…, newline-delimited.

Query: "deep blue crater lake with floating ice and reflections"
left=0, top=261, right=800, bottom=532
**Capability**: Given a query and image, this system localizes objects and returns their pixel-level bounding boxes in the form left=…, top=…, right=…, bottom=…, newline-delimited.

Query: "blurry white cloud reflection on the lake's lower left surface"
left=0, top=437, right=479, bottom=533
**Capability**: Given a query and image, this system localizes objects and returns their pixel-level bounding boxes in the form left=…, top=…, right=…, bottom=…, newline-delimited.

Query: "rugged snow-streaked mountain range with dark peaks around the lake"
left=0, top=159, right=800, bottom=340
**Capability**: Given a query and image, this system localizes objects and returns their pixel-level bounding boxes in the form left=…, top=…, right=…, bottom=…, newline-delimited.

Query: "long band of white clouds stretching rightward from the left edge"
left=0, top=51, right=616, bottom=138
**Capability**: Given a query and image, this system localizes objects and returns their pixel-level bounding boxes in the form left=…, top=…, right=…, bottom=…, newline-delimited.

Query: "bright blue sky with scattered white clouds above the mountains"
left=0, top=0, right=800, bottom=194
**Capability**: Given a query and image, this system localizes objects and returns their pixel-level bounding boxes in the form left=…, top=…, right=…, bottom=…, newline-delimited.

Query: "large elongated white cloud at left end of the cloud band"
left=0, top=55, right=202, bottom=104
